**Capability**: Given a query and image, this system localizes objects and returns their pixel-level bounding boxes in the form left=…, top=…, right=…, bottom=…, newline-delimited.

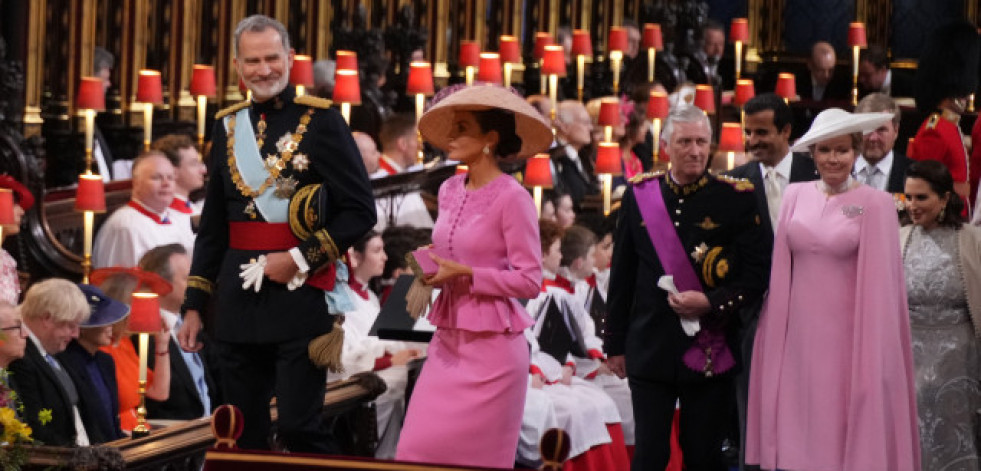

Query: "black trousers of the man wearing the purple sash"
left=629, top=377, right=735, bottom=471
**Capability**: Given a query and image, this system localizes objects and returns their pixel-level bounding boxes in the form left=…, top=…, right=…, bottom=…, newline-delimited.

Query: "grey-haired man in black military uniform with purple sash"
left=604, top=107, right=770, bottom=470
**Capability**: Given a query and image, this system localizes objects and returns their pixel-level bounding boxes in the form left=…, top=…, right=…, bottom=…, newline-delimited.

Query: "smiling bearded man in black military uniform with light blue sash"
left=179, top=15, right=375, bottom=453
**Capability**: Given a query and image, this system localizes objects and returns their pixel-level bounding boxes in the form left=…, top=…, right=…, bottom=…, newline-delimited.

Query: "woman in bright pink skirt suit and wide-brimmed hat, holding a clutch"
left=396, top=85, right=552, bottom=468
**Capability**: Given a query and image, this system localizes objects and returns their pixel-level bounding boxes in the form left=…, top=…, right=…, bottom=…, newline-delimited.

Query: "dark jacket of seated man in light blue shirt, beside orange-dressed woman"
left=146, top=337, right=217, bottom=420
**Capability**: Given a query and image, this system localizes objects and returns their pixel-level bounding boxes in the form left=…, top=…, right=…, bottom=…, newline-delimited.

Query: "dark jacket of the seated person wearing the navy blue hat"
left=55, top=340, right=125, bottom=444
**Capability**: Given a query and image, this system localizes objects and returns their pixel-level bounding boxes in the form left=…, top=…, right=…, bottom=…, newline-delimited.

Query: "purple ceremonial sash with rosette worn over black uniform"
left=634, top=175, right=736, bottom=377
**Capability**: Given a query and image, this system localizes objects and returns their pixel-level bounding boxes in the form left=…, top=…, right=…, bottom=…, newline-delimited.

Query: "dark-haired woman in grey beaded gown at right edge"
left=900, top=160, right=981, bottom=471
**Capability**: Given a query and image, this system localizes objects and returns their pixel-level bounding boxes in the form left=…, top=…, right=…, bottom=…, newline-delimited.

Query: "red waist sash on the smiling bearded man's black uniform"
left=228, top=221, right=337, bottom=291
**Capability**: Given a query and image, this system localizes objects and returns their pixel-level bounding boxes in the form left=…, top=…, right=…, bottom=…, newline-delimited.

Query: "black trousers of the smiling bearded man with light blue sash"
left=218, top=338, right=339, bottom=454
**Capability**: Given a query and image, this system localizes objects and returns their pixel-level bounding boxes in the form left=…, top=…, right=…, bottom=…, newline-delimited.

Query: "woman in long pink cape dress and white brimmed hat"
left=746, top=109, right=920, bottom=471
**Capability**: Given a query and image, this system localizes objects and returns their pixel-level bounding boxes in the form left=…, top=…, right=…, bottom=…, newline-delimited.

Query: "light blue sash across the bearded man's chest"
left=225, top=108, right=290, bottom=223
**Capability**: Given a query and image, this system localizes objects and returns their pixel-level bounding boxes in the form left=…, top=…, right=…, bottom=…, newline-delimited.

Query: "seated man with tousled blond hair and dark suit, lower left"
left=9, top=278, right=90, bottom=446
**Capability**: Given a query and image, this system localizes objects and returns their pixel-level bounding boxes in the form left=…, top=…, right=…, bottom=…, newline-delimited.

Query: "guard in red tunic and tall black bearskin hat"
left=910, top=21, right=981, bottom=211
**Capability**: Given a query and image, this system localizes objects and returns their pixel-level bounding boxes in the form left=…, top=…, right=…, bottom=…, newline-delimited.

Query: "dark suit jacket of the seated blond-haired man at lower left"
left=8, top=339, right=82, bottom=446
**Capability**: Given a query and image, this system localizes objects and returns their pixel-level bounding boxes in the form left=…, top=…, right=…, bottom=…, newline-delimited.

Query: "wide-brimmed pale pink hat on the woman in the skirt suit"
left=419, top=85, right=552, bottom=157
